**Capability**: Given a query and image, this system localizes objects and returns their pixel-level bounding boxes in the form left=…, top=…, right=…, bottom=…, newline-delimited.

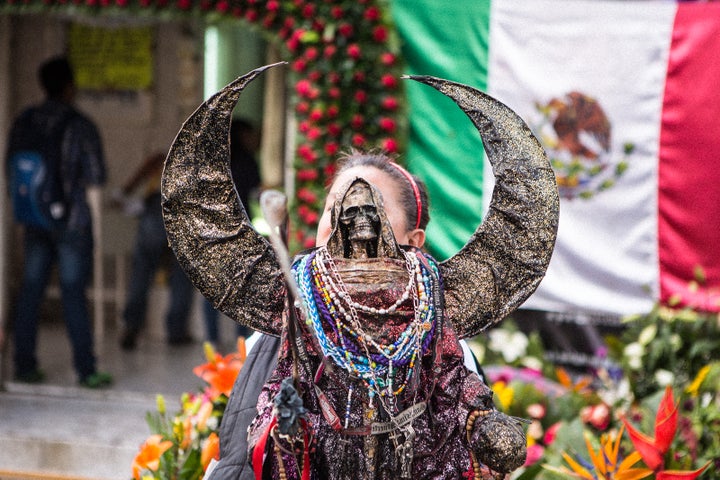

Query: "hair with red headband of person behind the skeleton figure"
left=334, top=149, right=430, bottom=230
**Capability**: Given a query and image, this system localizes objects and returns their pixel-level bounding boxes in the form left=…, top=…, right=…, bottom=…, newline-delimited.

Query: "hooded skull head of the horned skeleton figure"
left=338, top=182, right=380, bottom=258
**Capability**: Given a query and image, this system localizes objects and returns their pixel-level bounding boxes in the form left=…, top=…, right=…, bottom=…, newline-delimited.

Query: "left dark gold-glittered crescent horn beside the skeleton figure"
left=161, top=62, right=286, bottom=335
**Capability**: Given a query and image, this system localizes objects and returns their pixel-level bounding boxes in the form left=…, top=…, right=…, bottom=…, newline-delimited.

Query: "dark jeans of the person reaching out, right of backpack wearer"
left=124, top=194, right=195, bottom=341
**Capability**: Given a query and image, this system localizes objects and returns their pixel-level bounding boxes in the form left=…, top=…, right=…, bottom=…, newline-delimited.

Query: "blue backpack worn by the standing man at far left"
left=7, top=110, right=71, bottom=230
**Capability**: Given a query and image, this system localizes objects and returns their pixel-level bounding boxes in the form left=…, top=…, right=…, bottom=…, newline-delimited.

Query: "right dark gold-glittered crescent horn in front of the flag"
left=406, top=76, right=560, bottom=338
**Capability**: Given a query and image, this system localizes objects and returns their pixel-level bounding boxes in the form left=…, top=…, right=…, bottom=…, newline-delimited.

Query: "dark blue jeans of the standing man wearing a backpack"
left=15, top=228, right=95, bottom=379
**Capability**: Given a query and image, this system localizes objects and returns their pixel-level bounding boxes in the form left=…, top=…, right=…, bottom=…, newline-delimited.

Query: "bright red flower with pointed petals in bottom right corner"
left=622, top=386, right=709, bottom=480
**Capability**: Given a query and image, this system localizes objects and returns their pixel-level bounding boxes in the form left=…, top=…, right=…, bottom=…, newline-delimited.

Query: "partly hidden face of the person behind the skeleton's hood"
left=315, top=166, right=425, bottom=247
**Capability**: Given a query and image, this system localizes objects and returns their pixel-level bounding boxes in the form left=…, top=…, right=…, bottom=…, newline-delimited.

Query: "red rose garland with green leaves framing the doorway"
left=0, top=0, right=400, bottom=251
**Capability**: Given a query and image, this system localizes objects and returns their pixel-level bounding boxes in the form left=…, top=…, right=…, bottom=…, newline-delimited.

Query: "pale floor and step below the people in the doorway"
left=0, top=320, right=243, bottom=480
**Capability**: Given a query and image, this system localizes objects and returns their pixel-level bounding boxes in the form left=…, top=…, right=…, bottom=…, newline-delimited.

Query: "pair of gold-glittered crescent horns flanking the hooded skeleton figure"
left=162, top=64, right=559, bottom=338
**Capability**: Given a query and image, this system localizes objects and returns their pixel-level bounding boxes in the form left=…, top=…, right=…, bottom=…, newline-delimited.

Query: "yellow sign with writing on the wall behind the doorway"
left=68, top=24, right=153, bottom=90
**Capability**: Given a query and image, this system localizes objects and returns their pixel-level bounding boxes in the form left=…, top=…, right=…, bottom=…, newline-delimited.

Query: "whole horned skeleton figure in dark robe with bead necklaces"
left=163, top=63, right=558, bottom=479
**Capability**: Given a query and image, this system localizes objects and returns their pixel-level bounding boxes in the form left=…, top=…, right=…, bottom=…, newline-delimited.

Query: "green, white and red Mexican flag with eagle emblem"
left=392, top=0, right=720, bottom=315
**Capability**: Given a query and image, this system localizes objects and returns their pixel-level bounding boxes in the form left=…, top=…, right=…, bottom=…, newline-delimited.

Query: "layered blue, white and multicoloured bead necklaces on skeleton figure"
left=293, top=248, right=435, bottom=404
